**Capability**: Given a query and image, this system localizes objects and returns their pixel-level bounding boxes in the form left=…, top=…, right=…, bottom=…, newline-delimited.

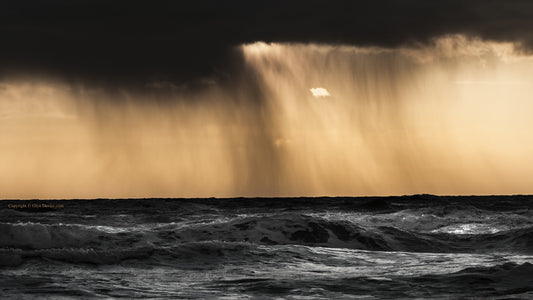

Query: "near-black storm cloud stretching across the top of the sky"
left=0, top=0, right=533, bottom=83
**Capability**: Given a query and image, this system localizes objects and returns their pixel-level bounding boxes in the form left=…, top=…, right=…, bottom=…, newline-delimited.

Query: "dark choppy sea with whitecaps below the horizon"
left=0, top=195, right=533, bottom=299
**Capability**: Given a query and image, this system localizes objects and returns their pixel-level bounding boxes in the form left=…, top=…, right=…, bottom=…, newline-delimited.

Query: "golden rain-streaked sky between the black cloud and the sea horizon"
left=0, top=36, right=533, bottom=198
